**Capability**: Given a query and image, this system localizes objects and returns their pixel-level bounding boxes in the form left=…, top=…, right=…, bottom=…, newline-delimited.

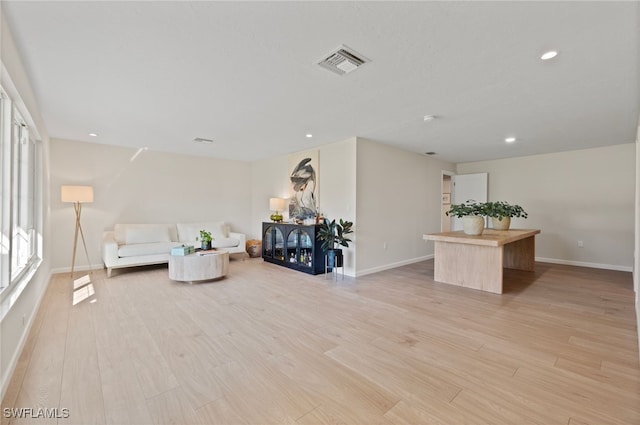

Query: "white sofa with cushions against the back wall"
left=102, top=221, right=248, bottom=277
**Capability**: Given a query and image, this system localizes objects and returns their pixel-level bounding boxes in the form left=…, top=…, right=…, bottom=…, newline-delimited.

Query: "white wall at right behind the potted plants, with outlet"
left=458, top=143, right=636, bottom=271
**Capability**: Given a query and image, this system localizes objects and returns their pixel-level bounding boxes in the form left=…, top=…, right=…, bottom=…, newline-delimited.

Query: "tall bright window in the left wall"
left=0, top=87, right=42, bottom=295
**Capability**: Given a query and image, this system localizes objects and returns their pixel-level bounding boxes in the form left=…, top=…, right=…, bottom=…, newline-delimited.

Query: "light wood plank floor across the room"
left=2, top=259, right=640, bottom=425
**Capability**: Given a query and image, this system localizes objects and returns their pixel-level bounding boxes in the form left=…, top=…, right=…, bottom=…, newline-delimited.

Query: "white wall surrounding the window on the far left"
left=0, top=7, right=51, bottom=398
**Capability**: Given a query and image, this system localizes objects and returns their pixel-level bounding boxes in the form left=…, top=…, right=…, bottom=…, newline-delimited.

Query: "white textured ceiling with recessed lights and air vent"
left=2, top=1, right=640, bottom=162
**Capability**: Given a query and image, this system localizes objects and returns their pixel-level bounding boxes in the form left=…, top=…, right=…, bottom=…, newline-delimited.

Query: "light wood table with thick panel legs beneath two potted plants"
left=423, top=229, right=540, bottom=294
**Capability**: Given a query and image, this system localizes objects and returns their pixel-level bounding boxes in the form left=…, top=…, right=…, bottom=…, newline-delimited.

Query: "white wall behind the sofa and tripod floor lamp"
left=50, top=139, right=252, bottom=271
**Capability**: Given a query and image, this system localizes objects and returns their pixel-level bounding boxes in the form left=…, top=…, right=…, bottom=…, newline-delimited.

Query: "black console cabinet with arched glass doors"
left=262, top=222, right=324, bottom=274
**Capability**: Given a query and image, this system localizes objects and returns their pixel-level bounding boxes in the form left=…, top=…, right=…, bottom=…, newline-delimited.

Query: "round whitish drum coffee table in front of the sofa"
left=169, top=249, right=229, bottom=283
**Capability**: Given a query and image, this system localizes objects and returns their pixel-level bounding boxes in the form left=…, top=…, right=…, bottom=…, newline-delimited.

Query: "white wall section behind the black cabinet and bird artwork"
left=251, top=137, right=358, bottom=276
